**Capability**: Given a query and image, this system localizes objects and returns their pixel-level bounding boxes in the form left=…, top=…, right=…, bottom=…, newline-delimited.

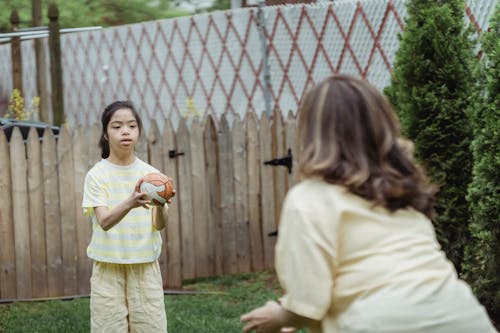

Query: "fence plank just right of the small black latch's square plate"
left=177, top=119, right=196, bottom=279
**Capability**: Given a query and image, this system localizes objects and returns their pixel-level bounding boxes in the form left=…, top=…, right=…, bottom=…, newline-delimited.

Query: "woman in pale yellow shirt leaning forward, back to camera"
left=241, top=75, right=496, bottom=333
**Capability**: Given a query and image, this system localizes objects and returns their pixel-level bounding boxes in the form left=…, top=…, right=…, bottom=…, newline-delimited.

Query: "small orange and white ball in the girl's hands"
left=139, top=172, right=175, bottom=205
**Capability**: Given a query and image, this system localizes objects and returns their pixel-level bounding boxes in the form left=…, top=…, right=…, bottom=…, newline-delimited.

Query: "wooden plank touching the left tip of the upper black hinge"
left=260, top=113, right=276, bottom=268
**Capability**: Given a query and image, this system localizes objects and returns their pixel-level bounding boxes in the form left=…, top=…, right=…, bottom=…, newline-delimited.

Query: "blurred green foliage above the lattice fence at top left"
left=0, top=0, right=189, bottom=32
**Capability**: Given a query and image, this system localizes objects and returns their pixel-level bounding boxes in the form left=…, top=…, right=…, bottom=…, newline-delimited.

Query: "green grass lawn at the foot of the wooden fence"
left=0, top=271, right=304, bottom=333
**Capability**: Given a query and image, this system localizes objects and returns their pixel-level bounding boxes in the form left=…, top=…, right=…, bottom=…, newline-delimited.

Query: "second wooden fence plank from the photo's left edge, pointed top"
left=10, top=127, right=32, bottom=298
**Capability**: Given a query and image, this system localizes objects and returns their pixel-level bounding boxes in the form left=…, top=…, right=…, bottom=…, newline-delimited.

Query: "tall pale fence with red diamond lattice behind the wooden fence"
left=0, top=0, right=496, bottom=128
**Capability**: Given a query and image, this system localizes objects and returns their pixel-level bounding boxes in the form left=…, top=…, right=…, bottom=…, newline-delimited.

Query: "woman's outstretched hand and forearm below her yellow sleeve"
left=241, top=301, right=297, bottom=333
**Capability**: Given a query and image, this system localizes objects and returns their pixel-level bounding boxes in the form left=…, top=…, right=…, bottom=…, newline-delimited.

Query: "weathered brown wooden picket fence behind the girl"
left=0, top=113, right=297, bottom=299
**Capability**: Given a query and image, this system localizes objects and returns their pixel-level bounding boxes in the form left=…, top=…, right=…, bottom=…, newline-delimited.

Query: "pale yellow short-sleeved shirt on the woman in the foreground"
left=276, top=179, right=495, bottom=333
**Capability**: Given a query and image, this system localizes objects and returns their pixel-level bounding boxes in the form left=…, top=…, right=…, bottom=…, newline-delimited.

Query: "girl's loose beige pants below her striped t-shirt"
left=90, top=261, right=167, bottom=333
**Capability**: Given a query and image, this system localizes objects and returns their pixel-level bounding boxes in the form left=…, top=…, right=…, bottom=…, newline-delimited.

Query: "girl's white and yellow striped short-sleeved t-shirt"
left=82, top=158, right=162, bottom=264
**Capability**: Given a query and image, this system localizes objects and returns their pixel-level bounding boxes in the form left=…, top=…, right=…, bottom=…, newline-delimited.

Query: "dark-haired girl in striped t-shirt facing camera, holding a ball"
left=82, top=101, right=168, bottom=332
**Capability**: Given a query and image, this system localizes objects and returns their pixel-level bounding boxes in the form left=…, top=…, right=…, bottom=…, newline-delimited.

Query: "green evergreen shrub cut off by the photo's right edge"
left=464, top=3, right=500, bottom=323
